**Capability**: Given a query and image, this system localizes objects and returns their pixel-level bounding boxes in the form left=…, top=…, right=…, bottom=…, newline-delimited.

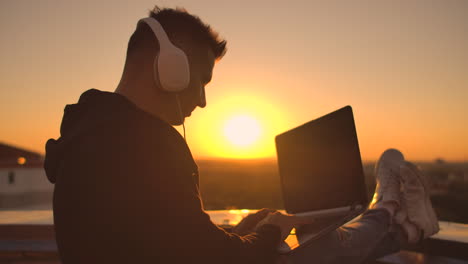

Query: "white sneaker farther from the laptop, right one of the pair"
left=395, top=162, right=439, bottom=238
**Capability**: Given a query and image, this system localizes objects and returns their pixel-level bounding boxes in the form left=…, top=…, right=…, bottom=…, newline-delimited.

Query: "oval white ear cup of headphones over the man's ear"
left=154, top=45, right=190, bottom=92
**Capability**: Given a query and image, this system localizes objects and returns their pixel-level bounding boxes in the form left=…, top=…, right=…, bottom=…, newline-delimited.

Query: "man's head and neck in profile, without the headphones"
left=117, top=7, right=226, bottom=125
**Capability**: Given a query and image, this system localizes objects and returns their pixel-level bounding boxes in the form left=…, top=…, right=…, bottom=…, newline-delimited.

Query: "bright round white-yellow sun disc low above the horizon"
left=224, top=115, right=262, bottom=148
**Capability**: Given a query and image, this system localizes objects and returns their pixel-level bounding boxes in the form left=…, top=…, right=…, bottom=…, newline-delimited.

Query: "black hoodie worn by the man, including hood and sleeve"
left=44, top=89, right=280, bottom=264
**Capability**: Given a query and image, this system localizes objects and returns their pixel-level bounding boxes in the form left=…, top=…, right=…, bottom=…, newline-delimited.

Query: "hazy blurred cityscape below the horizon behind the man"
left=0, top=141, right=468, bottom=223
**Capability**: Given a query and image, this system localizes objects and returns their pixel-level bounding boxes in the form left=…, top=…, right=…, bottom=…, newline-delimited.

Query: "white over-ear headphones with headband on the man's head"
left=138, top=17, right=190, bottom=92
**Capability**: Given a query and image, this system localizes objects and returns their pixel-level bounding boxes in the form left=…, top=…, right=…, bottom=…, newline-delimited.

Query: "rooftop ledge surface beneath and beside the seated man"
left=0, top=210, right=468, bottom=264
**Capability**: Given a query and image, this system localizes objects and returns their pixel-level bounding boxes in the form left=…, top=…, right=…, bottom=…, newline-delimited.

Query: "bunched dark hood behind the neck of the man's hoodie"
left=44, top=89, right=131, bottom=183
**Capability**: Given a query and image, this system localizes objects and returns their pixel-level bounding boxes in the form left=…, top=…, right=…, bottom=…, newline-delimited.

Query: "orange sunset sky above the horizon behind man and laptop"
left=0, top=0, right=468, bottom=161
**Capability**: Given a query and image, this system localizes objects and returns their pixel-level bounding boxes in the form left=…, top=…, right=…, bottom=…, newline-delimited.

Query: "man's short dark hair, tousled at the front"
left=127, top=6, right=226, bottom=60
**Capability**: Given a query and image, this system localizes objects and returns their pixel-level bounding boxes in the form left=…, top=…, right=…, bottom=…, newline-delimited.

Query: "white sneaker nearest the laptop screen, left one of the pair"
left=369, top=149, right=405, bottom=208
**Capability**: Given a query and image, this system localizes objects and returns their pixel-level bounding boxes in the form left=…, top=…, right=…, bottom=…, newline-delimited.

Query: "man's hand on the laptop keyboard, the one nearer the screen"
left=255, top=212, right=312, bottom=240
